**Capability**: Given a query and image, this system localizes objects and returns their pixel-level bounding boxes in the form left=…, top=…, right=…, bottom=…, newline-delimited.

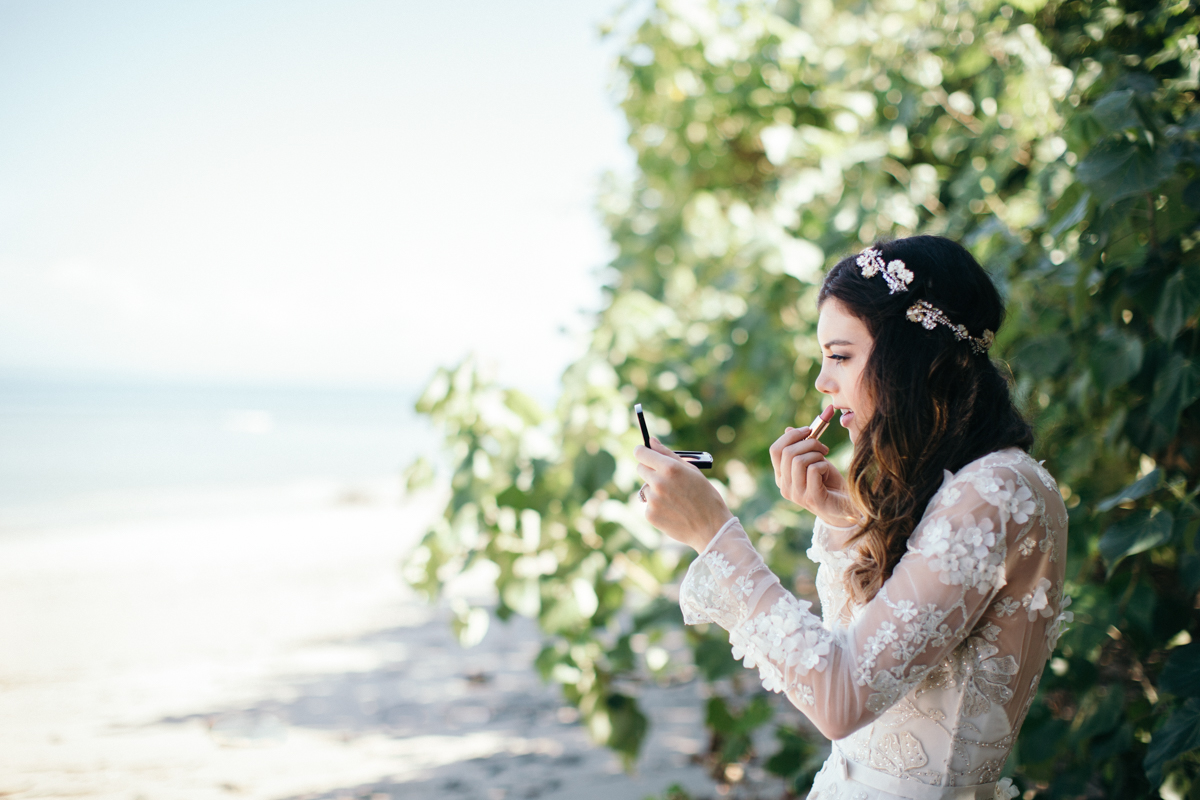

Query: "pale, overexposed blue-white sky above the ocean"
left=0, top=0, right=632, bottom=396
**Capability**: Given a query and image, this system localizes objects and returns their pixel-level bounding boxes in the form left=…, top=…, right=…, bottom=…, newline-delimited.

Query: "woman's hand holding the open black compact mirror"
left=634, top=439, right=733, bottom=553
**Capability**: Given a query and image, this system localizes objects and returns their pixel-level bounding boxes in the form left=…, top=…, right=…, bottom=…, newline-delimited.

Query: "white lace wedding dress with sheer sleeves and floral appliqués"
left=679, top=449, right=1072, bottom=800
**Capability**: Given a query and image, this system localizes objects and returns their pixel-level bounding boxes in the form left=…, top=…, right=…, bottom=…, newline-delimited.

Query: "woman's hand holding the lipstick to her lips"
left=770, top=427, right=859, bottom=528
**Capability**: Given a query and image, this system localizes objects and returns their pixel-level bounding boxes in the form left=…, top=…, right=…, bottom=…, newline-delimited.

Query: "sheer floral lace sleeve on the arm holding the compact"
left=679, top=467, right=1045, bottom=739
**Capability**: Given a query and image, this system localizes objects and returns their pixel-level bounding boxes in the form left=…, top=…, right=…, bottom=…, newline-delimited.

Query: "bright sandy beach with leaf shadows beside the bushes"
left=0, top=495, right=779, bottom=800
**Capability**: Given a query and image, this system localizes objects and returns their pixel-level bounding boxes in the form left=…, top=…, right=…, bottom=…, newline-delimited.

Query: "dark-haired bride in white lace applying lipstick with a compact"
left=635, top=236, right=1072, bottom=800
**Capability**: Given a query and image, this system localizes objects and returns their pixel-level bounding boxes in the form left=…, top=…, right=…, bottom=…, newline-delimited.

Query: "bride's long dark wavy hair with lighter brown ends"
left=817, top=236, right=1033, bottom=603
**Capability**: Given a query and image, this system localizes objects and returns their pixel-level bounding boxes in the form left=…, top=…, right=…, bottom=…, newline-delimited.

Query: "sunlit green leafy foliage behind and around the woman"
left=406, top=0, right=1200, bottom=798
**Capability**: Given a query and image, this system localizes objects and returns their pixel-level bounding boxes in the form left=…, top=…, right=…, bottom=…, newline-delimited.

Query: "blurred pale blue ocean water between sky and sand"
left=0, top=378, right=438, bottom=534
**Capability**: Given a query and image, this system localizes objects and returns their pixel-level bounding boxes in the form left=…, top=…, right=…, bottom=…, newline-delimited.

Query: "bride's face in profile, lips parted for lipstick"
left=816, top=297, right=875, bottom=441
